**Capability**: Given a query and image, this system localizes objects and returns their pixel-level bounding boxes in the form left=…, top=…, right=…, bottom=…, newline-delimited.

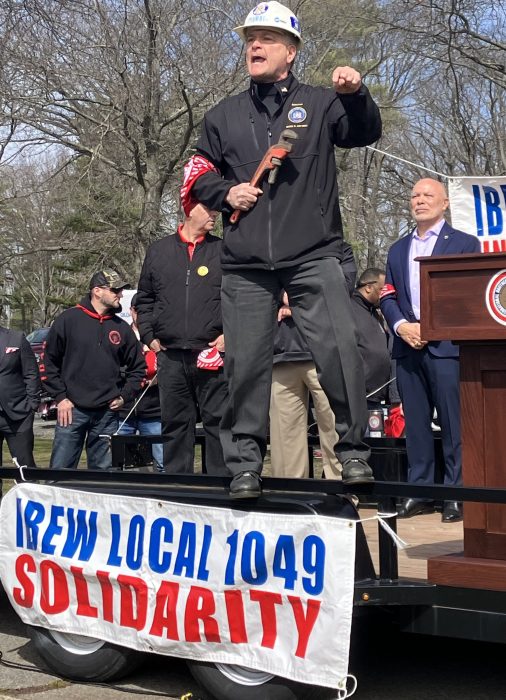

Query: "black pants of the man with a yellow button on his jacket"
left=158, top=350, right=227, bottom=475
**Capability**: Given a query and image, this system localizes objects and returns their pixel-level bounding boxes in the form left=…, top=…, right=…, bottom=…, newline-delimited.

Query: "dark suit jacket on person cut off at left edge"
left=0, top=326, right=42, bottom=421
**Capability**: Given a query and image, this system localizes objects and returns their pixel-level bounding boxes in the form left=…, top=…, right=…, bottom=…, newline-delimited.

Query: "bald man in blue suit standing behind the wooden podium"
left=381, top=178, right=480, bottom=522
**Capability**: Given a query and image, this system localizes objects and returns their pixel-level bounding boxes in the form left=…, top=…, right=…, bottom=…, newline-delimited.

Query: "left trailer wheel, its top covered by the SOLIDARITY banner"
left=27, top=625, right=143, bottom=682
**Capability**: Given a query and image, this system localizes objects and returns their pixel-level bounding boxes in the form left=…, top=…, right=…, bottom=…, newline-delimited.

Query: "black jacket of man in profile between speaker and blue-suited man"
left=351, top=291, right=391, bottom=401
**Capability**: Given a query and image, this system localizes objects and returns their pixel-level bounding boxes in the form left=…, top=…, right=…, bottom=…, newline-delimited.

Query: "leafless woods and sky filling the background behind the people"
left=0, top=0, right=506, bottom=323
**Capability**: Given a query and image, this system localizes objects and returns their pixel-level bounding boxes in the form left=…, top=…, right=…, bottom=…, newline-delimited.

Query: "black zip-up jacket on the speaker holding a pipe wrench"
left=193, top=74, right=381, bottom=269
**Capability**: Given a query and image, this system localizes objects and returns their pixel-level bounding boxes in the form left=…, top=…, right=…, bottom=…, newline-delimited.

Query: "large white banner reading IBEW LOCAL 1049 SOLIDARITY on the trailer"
left=0, top=483, right=355, bottom=688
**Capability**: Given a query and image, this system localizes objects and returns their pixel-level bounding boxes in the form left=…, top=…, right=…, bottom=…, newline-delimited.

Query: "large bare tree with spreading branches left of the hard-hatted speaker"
left=2, top=0, right=251, bottom=269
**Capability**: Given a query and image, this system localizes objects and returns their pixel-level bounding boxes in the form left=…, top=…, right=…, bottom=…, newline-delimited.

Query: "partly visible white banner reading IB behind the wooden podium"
left=448, top=177, right=506, bottom=253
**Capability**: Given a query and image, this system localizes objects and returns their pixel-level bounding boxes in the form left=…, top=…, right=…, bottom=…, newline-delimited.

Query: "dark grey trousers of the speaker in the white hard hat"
left=221, top=260, right=370, bottom=474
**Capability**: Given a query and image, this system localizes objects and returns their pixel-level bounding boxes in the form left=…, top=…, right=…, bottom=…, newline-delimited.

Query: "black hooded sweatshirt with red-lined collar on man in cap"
left=41, top=296, right=146, bottom=410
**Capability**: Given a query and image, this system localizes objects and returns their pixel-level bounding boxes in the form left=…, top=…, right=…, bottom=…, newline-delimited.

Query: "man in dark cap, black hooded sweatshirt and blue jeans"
left=40, top=269, right=146, bottom=469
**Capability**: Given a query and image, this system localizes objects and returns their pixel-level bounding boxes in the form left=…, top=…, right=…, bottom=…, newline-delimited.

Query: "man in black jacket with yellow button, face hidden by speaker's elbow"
left=136, top=156, right=227, bottom=475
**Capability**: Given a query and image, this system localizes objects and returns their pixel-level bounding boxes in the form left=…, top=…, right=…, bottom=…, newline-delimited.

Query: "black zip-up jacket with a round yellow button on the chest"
left=137, top=233, right=223, bottom=350
